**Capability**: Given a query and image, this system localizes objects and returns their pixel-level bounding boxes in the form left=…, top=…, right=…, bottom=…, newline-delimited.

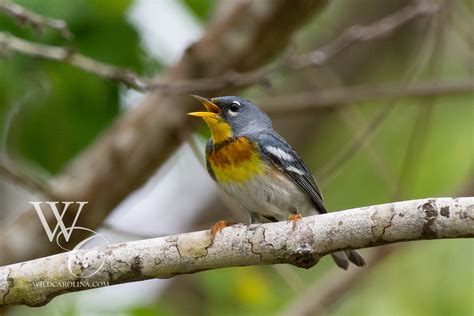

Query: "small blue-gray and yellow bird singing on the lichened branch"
left=188, top=95, right=365, bottom=270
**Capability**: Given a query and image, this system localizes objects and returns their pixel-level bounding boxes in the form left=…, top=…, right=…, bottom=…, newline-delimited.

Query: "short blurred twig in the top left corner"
left=0, top=0, right=72, bottom=39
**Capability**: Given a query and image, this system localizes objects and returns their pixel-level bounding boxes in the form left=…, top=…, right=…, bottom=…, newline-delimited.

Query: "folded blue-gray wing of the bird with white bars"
left=254, top=132, right=327, bottom=213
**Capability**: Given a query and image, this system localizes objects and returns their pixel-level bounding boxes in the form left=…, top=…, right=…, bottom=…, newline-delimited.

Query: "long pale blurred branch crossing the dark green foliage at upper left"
left=0, top=32, right=144, bottom=90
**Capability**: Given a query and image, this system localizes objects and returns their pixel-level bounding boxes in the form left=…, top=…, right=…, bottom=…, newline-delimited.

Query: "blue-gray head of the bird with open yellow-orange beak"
left=189, top=96, right=272, bottom=142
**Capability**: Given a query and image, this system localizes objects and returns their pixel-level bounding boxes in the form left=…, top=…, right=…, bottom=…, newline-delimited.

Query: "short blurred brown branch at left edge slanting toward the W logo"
left=0, top=155, right=54, bottom=197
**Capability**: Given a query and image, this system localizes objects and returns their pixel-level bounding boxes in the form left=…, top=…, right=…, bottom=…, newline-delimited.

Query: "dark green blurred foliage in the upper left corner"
left=0, top=0, right=145, bottom=174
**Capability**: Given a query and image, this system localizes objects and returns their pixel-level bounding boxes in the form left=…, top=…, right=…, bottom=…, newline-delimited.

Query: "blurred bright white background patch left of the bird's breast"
left=107, top=139, right=217, bottom=236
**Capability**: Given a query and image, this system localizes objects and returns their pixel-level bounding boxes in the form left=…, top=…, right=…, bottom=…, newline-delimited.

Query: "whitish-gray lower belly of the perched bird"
left=220, top=167, right=315, bottom=220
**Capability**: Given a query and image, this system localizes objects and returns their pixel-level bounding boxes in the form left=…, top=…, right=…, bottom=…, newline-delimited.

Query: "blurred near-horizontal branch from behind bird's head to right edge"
left=258, top=80, right=474, bottom=115
